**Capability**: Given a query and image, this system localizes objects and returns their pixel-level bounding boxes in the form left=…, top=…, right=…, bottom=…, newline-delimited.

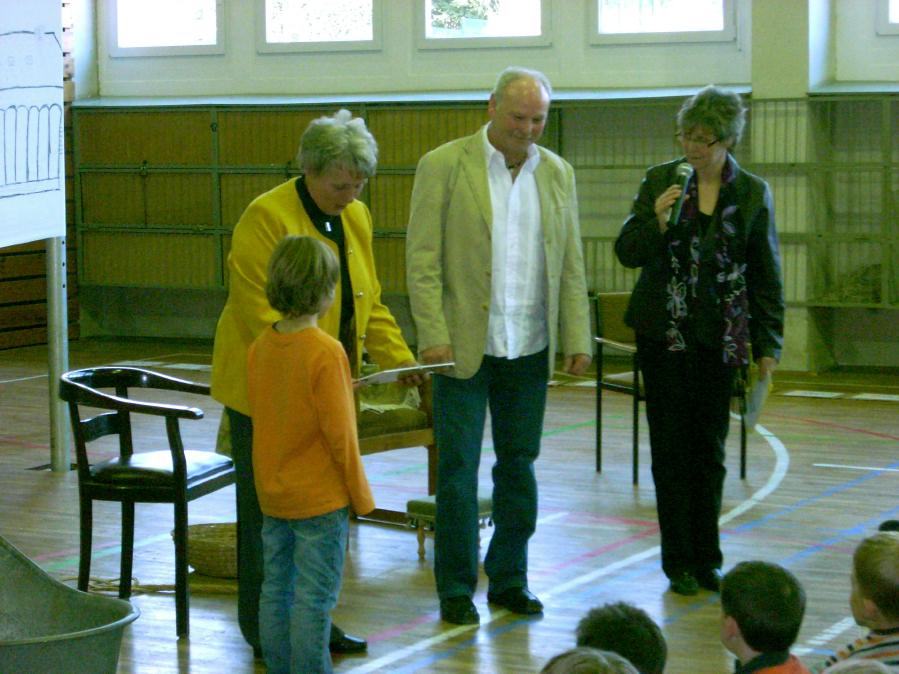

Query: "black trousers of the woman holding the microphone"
left=637, top=335, right=736, bottom=577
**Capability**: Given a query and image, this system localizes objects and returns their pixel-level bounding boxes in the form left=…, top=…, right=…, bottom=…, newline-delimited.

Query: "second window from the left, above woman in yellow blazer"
left=256, top=0, right=381, bottom=53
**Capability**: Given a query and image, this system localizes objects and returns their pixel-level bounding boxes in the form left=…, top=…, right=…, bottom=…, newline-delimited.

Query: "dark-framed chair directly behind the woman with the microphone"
left=591, top=292, right=746, bottom=484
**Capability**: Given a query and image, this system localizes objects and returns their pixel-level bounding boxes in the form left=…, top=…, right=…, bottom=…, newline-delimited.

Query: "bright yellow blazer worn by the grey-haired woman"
left=211, top=179, right=414, bottom=415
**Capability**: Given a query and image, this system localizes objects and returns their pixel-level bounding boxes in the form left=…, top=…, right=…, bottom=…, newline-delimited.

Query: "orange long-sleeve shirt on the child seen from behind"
left=247, top=327, right=374, bottom=519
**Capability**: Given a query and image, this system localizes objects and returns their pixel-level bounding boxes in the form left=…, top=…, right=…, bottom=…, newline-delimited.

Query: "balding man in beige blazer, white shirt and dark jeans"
left=406, top=68, right=592, bottom=624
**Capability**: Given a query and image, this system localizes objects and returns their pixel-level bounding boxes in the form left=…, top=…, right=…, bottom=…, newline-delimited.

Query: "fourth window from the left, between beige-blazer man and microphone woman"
left=590, top=0, right=736, bottom=44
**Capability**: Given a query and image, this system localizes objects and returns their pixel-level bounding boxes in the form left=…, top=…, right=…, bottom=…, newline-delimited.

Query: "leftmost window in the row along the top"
left=109, top=0, right=225, bottom=56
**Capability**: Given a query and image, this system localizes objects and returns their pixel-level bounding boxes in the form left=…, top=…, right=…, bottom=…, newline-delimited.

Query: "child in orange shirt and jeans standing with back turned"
left=247, top=236, right=374, bottom=674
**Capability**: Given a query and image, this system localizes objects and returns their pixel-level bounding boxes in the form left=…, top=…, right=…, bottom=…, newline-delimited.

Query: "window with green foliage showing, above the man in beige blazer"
left=418, top=0, right=549, bottom=49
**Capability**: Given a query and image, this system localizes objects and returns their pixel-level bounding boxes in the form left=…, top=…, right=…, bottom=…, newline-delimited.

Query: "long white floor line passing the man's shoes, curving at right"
left=347, top=418, right=790, bottom=674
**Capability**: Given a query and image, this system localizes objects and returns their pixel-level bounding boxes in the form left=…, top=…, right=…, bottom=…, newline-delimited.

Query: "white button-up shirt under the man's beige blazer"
left=483, top=126, right=549, bottom=358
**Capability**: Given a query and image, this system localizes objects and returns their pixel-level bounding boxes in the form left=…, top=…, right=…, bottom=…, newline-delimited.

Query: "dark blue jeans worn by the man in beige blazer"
left=434, top=349, right=548, bottom=599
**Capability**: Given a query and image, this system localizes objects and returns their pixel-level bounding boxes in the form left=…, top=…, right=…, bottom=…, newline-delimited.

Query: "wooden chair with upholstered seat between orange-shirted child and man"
left=358, top=379, right=437, bottom=525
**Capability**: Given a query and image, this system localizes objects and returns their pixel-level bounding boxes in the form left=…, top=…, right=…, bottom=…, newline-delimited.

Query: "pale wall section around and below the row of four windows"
left=91, top=0, right=750, bottom=96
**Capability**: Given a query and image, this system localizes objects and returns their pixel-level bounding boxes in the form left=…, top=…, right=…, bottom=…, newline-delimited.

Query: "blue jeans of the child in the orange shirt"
left=259, top=508, right=349, bottom=674
